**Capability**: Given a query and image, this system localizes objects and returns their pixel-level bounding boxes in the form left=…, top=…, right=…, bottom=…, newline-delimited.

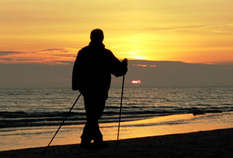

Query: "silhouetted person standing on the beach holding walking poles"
left=72, top=29, right=128, bottom=147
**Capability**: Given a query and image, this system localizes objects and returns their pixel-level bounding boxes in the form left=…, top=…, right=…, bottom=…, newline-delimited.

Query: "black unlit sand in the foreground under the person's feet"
left=0, top=128, right=233, bottom=158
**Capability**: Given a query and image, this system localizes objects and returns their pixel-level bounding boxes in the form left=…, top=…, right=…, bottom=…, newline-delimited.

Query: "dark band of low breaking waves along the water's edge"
left=0, top=106, right=233, bottom=128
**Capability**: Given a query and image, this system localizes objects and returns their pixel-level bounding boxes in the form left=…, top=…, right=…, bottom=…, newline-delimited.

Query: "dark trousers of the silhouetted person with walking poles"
left=81, top=95, right=106, bottom=143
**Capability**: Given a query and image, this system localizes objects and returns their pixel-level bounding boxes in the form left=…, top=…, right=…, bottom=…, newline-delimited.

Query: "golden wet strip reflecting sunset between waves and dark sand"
left=0, top=113, right=233, bottom=151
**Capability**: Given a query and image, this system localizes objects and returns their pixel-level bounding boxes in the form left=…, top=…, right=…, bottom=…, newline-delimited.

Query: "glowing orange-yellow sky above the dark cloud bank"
left=0, top=0, right=233, bottom=63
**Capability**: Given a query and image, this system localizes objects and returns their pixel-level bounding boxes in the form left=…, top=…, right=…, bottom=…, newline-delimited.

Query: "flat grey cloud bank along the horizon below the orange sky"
left=0, top=60, right=233, bottom=88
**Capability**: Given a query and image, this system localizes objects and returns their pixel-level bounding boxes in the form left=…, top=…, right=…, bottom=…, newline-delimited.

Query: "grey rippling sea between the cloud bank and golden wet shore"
left=0, top=87, right=233, bottom=150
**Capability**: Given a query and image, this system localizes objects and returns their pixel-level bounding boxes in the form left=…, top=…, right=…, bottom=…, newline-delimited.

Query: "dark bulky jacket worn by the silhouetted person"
left=72, top=42, right=127, bottom=98
